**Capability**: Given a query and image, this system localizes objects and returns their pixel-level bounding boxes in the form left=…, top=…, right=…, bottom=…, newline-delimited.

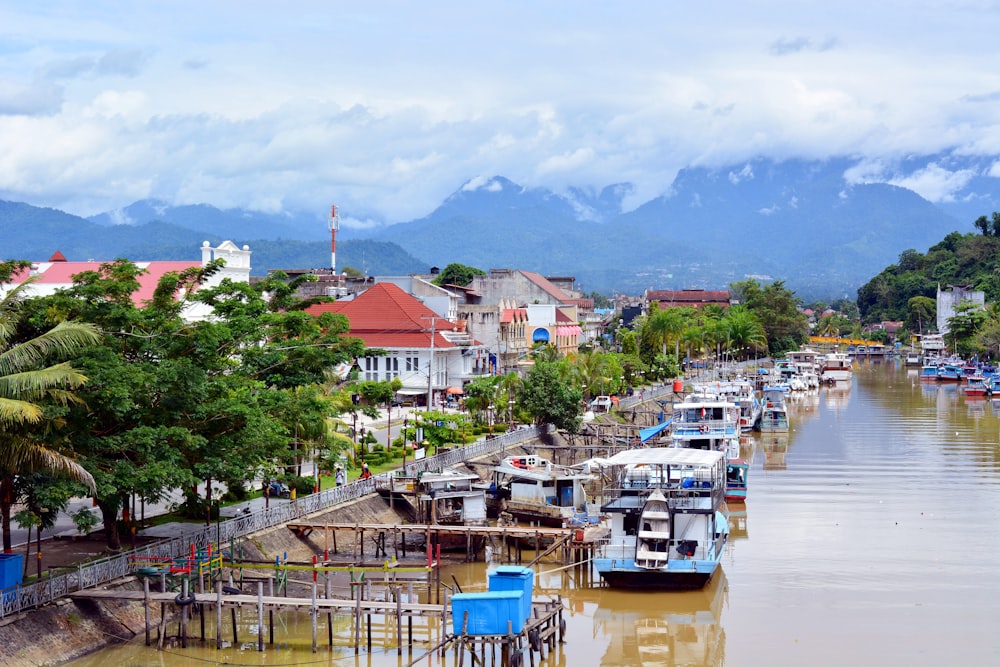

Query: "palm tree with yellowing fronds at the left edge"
left=0, top=281, right=100, bottom=553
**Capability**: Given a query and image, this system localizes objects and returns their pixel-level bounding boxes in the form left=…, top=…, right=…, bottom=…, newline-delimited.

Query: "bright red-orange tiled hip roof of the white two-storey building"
left=306, top=283, right=456, bottom=348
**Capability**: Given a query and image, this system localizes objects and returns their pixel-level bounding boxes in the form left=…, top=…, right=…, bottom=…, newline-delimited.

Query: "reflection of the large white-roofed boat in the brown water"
left=594, top=571, right=728, bottom=667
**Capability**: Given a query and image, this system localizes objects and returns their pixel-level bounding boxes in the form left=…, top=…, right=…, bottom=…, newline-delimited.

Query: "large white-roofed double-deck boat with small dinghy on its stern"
left=593, top=447, right=729, bottom=590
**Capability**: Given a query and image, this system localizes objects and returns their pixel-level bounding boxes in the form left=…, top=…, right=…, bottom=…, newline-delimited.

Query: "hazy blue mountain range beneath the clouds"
left=0, top=156, right=1000, bottom=300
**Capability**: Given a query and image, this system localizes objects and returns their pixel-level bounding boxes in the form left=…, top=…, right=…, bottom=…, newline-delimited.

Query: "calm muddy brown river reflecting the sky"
left=64, top=360, right=1000, bottom=667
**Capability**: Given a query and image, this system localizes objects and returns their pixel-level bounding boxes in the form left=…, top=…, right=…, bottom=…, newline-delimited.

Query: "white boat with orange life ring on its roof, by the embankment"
left=488, top=454, right=596, bottom=528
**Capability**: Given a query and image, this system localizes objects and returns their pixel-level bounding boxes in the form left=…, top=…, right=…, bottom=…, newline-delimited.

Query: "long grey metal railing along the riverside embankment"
left=0, top=427, right=541, bottom=619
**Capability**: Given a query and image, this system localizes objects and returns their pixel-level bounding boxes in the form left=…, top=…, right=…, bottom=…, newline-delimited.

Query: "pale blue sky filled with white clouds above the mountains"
left=0, top=0, right=1000, bottom=226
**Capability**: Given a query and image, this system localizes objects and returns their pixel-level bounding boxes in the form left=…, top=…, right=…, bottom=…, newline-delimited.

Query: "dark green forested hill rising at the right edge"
left=858, top=226, right=1000, bottom=332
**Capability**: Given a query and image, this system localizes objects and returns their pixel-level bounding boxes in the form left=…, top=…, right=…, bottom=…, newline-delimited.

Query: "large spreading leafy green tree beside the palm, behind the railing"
left=28, top=260, right=364, bottom=548
